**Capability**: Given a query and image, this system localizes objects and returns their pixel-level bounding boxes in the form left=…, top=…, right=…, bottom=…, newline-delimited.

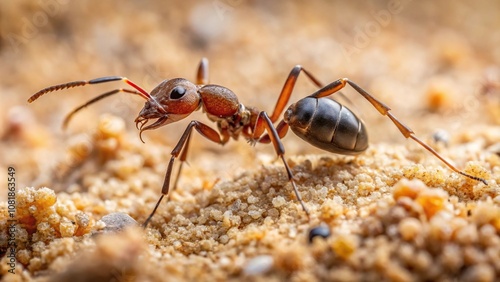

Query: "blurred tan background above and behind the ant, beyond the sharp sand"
left=0, top=0, right=500, bottom=192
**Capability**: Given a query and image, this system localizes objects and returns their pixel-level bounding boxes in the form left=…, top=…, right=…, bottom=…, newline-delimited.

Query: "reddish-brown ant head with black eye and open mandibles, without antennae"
left=135, top=78, right=201, bottom=140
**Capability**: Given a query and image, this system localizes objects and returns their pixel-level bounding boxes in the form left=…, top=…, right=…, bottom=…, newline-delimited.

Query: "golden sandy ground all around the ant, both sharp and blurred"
left=0, top=0, right=500, bottom=281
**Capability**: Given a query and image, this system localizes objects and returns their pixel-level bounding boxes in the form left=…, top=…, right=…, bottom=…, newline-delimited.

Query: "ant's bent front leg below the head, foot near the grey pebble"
left=143, top=120, right=223, bottom=228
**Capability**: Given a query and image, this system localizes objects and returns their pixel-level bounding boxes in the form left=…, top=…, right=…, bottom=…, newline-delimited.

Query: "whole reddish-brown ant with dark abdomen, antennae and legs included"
left=28, top=58, right=487, bottom=228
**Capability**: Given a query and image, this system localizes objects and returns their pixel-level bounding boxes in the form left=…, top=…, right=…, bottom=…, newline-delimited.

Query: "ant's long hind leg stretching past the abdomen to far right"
left=309, top=78, right=488, bottom=185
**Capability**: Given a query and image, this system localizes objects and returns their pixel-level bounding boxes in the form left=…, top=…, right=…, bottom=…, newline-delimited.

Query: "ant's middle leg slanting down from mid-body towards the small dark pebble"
left=259, top=112, right=309, bottom=218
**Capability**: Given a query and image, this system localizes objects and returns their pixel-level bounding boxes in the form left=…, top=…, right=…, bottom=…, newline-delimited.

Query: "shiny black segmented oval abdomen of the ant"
left=284, top=97, right=368, bottom=155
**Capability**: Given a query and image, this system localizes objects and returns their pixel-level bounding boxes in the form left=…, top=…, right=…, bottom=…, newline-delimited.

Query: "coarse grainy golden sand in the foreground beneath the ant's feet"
left=2, top=115, right=500, bottom=281
